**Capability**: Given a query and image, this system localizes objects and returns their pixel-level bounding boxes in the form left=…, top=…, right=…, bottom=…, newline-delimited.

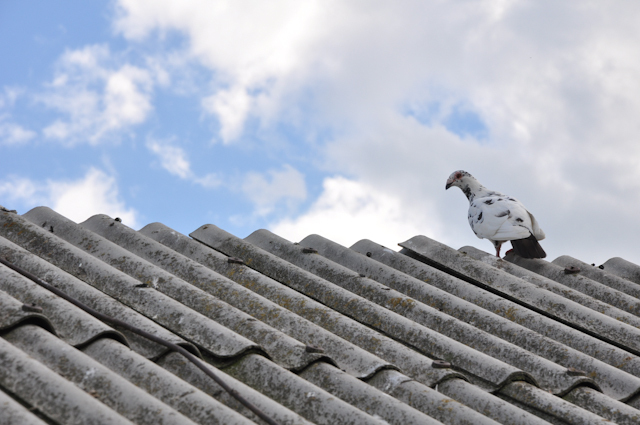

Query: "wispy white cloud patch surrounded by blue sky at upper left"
left=38, top=45, right=158, bottom=145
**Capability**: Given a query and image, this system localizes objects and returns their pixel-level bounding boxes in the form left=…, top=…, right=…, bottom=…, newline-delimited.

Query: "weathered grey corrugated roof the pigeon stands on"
left=0, top=207, right=640, bottom=425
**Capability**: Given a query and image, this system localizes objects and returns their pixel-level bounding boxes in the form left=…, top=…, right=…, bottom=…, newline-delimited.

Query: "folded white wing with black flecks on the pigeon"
left=469, top=196, right=533, bottom=241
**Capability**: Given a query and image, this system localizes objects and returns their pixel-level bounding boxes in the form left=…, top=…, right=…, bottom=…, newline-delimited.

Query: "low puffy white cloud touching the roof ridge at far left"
left=0, top=168, right=139, bottom=228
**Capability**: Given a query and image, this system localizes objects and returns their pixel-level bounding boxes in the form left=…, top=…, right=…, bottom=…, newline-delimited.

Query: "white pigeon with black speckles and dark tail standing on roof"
left=445, top=170, right=547, bottom=258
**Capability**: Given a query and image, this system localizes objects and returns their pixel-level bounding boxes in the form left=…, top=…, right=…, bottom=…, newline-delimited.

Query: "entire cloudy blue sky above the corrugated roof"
left=0, top=0, right=640, bottom=264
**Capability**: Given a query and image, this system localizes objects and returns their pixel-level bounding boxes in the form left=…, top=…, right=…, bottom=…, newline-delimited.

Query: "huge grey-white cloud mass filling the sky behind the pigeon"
left=116, top=0, right=640, bottom=262
